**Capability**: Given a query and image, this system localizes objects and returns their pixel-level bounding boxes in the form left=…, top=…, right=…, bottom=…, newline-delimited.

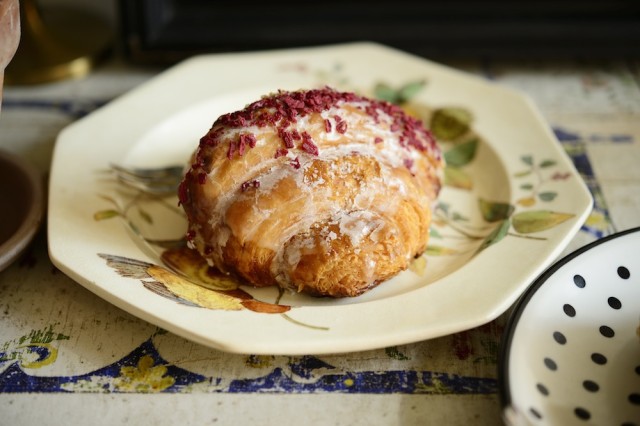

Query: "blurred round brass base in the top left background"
left=5, top=0, right=112, bottom=85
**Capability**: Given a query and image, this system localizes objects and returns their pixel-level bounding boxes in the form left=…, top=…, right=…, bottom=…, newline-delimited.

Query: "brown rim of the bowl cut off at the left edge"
left=0, top=149, right=44, bottom=271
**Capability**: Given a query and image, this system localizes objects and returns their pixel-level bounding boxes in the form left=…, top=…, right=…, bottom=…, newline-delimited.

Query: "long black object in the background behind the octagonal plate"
left=120, top=0, right=640, bottom=64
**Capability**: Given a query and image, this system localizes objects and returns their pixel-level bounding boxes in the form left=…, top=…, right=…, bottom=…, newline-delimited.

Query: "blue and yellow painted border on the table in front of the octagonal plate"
left=0, top=339, right=497, bottom=395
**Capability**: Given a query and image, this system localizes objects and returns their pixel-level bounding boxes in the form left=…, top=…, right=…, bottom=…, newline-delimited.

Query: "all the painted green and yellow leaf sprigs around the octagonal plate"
left=94, top=81, right=574, bottom=319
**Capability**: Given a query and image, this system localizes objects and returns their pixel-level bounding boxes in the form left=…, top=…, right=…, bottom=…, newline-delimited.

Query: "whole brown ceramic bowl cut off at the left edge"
left=0, top=150, right=44, bottom=271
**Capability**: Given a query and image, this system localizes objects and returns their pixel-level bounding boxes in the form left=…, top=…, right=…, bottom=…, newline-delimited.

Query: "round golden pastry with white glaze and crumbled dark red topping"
left=178, top=88, right=444, bottom=297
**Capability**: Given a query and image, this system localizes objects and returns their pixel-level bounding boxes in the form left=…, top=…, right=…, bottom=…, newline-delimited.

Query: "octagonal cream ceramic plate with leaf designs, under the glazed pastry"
left=48, top=43, right=592, bottom=354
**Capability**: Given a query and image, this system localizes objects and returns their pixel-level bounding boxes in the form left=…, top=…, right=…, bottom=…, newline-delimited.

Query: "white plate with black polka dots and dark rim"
left=500, top=228, right=640, bottom=426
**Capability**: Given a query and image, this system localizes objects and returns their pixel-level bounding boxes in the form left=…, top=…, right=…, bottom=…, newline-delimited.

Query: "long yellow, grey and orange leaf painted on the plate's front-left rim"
left=98, top=253, right=291, bottom=313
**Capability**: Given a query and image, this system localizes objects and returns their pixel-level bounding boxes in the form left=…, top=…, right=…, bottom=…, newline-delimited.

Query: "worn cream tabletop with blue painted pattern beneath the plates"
left=0, top=54, right=640, bottom=425
